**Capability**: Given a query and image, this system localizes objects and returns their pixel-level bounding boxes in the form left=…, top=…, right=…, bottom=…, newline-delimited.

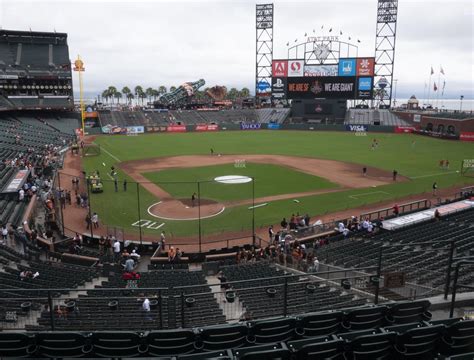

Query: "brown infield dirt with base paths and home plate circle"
left=117, top=155, right=408, bottom=220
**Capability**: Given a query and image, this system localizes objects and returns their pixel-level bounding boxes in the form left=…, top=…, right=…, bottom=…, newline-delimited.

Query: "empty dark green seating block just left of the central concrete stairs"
left=33, top=270, right=225, bottom=331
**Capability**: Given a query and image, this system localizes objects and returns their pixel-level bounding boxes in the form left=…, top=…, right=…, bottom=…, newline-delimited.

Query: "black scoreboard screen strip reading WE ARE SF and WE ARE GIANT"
left=287, top=76, right=356, bottom=99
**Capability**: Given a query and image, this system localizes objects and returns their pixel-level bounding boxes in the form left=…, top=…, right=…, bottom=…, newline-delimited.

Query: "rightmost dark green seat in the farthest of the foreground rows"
left=387, top=300, right=431, bottom=324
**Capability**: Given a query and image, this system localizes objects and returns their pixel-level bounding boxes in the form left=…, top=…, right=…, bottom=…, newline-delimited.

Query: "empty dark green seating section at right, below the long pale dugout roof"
left=316, top=210, right=474, bottom=294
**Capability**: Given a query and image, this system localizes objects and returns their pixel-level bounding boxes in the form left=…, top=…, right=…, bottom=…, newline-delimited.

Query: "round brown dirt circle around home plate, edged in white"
left=148, top=199, right=225, bottom=220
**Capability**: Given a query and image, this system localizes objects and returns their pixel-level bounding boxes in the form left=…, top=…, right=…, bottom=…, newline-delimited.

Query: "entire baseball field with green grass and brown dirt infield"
left=75, top=130, right=474, bottom=242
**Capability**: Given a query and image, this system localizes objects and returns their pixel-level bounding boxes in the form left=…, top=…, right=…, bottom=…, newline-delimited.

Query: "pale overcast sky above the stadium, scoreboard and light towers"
left=0, top=0, right=474, bottom=98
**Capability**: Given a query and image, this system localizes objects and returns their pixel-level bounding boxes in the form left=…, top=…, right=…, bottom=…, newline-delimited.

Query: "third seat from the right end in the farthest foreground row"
left=296, top=311, right=343, bottom=337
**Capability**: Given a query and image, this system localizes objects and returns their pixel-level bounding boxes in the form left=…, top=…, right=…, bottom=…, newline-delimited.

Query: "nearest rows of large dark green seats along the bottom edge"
left=0, top=302, right=474, bottom=360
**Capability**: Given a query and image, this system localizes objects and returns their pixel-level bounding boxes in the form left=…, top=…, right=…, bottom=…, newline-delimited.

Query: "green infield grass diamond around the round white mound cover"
left=143, top=162, right=338, bottom=202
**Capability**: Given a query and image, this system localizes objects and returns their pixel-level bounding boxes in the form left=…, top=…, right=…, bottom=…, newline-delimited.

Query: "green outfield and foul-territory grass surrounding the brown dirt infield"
left=84, top=131, right=474, bottom=236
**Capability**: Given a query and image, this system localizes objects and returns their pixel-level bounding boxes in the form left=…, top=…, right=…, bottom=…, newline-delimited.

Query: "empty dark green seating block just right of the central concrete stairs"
left=222, top=263, right=367, bottom=318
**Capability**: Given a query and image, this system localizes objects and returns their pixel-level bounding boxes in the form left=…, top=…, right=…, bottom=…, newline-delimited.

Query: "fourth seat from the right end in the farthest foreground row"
left=248, top=318, right=296, bottom=344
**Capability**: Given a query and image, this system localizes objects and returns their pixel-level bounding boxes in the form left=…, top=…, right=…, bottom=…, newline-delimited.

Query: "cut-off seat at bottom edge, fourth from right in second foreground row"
left=287, top=336, right=345, bottom=360
